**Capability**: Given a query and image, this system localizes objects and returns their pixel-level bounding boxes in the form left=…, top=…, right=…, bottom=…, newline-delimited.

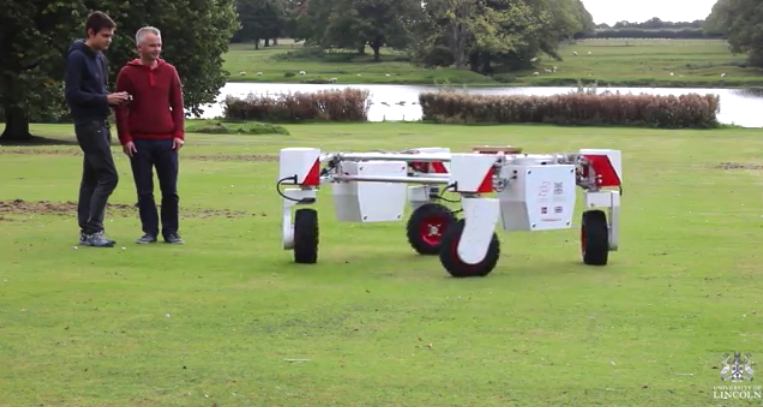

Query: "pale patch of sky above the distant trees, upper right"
left=582, top=0, right=717, bottom=25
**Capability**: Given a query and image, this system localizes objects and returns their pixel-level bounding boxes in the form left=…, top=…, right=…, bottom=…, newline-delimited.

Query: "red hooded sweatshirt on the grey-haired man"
left=115, top=59, right=185, bottom=145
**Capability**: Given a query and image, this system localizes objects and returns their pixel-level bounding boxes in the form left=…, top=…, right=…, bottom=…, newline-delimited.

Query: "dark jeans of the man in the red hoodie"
left=130, top=139, right=180, bottom=237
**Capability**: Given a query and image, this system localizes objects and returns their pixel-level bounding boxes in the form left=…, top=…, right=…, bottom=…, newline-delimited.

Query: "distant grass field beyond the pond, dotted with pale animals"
left=224, top=39, right=763, bottom=88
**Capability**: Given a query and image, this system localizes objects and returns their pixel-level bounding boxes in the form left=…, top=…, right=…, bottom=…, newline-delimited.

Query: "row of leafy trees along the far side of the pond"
left=233, top=0, right=595, bottom=74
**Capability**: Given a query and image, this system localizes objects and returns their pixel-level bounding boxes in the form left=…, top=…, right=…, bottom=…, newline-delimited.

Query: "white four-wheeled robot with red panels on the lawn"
left=276, top=147, right=622, bottom=277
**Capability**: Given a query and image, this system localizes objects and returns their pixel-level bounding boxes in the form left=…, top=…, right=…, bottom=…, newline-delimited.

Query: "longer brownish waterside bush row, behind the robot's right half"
left=419, top=92, right=720, bottom=128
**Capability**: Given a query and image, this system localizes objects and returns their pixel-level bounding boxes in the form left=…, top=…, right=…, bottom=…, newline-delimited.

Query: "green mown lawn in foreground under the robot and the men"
left=0, top=123, right=763, bottom=406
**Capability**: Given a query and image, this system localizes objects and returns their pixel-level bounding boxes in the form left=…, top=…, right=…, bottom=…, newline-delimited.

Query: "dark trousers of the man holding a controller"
left=74, top=120, right=119, bottom=234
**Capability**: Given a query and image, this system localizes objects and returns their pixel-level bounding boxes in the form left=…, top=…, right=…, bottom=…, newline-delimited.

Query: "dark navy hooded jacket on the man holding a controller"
left=64, top=40, right=111, bottom=122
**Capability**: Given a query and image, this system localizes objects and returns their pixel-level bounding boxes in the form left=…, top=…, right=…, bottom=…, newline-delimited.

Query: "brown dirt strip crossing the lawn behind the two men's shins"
left=0, top=199, right=256, bottom=221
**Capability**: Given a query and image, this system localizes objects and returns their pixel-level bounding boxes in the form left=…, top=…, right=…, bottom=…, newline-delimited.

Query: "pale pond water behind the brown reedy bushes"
left=202, top=82, right=763, bottom=128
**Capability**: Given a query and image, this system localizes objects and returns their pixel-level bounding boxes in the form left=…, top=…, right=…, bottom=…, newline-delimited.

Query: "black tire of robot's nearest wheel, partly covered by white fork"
left=440, top=219, right=501, bottom=278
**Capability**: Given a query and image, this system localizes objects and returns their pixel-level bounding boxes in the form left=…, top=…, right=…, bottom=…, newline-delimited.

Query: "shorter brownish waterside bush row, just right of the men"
left=224, top=89, right=370, bottom=122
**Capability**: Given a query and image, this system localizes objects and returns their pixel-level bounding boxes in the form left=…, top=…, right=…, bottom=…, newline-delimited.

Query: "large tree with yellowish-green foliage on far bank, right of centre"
left=412, top=0, right=594, bottom=74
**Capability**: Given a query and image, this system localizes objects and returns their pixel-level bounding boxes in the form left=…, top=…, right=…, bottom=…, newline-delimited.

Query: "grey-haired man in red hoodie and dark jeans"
left=116, top=27, right=185, bottom=244
